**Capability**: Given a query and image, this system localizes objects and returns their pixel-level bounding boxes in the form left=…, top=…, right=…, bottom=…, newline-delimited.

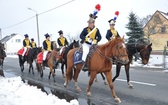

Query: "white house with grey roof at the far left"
left=0, top=34, right=24, bottom=55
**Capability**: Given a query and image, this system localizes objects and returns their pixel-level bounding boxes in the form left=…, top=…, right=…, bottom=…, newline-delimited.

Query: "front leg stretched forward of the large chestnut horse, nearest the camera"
left=105, top=70, right=121, bottom=103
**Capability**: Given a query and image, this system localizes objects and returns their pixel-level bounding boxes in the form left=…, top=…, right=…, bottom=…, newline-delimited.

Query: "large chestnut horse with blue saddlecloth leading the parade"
left=64, top=38, right=128, bottom=103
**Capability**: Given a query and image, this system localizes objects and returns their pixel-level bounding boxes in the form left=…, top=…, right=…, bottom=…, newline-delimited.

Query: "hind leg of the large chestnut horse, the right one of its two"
left=74, top=65, right=82, bottom=92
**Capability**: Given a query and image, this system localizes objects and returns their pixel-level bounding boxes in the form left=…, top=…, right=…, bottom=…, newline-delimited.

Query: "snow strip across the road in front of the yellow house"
left=131, top=55, right=168, bottom=68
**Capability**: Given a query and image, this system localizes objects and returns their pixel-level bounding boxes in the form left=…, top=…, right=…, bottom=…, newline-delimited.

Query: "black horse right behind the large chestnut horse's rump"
left=61, top=40, right=79, bottom=78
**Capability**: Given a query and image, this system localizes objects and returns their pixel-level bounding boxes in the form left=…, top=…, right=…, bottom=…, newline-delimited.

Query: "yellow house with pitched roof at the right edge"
left=144, top=10, right=168, bottom=52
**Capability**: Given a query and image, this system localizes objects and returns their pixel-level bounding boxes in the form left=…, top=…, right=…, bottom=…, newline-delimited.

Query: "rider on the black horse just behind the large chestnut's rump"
left=57, top=30, right=68, bottom=54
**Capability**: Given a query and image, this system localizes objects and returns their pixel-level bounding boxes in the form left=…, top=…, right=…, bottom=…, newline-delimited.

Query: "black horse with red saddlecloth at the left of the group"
left=18, top=47, right=41, bottom=75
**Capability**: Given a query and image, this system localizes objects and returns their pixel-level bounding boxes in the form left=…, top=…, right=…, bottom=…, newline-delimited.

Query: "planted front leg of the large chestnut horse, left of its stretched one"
left=87, top=71, right=97, bottom=96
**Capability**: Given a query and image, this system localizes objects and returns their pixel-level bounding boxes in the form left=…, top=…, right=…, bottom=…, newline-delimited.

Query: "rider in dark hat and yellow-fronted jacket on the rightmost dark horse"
left=106, top=19, right=120, bottom=41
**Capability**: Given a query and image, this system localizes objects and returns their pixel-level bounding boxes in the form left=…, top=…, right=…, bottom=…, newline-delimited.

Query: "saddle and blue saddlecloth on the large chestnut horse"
left=74, top=45, right=98, bottom=65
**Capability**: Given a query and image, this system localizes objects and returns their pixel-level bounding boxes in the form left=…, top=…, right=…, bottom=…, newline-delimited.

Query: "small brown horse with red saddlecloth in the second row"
left=36, top=49, right=61, bottom=82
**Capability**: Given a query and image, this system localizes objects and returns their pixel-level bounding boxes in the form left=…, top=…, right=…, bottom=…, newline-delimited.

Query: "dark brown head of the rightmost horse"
left=140, top=43, right=152, bottom=64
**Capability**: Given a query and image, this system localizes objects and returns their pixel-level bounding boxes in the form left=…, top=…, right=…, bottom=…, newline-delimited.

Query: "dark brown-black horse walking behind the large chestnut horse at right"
left=101, top=43, right=152, bottom=88
